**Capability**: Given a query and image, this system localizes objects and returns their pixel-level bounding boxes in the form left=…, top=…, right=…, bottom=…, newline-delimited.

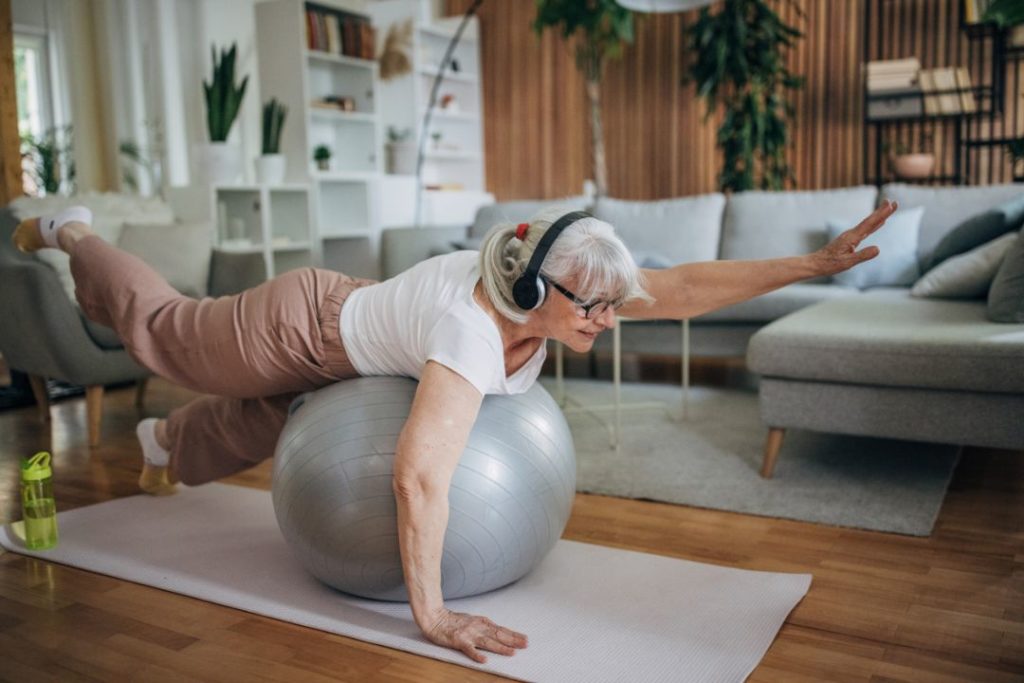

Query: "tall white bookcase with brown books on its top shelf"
left=250, top=0, right=383, bottom=278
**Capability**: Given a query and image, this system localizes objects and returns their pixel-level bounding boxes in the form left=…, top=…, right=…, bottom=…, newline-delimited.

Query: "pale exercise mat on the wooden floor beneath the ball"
left=0, top=483, right=811, bottom=683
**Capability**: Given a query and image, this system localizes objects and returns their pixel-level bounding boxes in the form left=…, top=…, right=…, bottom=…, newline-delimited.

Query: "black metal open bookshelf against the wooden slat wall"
left=863, top=0, right=1024, bottom=185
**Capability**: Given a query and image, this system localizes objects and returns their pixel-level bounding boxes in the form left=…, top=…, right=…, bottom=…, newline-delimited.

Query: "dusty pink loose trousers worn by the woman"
left=71, top=236, right=373, bottom=485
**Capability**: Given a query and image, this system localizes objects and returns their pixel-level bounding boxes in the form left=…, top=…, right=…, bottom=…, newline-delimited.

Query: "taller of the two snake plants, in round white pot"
left=200, top=43, right=249, bottom=184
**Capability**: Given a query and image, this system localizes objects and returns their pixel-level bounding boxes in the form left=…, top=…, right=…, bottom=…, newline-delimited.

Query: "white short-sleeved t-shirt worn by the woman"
left=340, top=251, right=547, bottom=394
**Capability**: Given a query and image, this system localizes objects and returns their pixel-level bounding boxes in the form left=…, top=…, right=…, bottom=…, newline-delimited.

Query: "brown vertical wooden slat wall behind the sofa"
left=447, top=0, right=1024, bottom=200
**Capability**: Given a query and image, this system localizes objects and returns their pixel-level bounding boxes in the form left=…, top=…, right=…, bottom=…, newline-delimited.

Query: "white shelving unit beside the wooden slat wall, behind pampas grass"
left=368, top=0, right=495, bottom=225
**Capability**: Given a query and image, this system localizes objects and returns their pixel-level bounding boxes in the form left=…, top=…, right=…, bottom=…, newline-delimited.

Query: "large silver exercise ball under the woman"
left=273, top=377, right=575, bottom=601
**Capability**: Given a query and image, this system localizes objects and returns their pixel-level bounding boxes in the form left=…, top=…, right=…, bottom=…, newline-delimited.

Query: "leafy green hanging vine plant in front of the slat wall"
left=686, top=0, right=804, bottom=191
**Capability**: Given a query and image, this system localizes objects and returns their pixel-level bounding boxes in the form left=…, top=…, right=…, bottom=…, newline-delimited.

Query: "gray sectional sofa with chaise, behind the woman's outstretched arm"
left=382, top=183, right=1024, bottom=476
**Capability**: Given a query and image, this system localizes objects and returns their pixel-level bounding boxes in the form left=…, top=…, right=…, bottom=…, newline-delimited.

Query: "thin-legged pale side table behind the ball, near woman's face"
left=555, top=317, right=690, bottom=449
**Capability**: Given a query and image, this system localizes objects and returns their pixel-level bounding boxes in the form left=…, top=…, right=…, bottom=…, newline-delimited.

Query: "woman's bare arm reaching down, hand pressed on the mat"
left=393, top=361, right=526, bottom=663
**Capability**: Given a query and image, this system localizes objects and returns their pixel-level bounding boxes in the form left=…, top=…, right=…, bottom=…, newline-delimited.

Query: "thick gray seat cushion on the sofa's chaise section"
left=748, top=289, right=1024, bottom=392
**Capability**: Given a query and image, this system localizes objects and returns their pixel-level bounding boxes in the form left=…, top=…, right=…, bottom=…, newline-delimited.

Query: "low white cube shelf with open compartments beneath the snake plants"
left=212, top=184, right=316, bottom=279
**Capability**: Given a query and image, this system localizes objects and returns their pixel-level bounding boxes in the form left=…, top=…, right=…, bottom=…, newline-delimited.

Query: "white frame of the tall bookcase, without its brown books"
left=255, top=0, right=383, bottom=278
